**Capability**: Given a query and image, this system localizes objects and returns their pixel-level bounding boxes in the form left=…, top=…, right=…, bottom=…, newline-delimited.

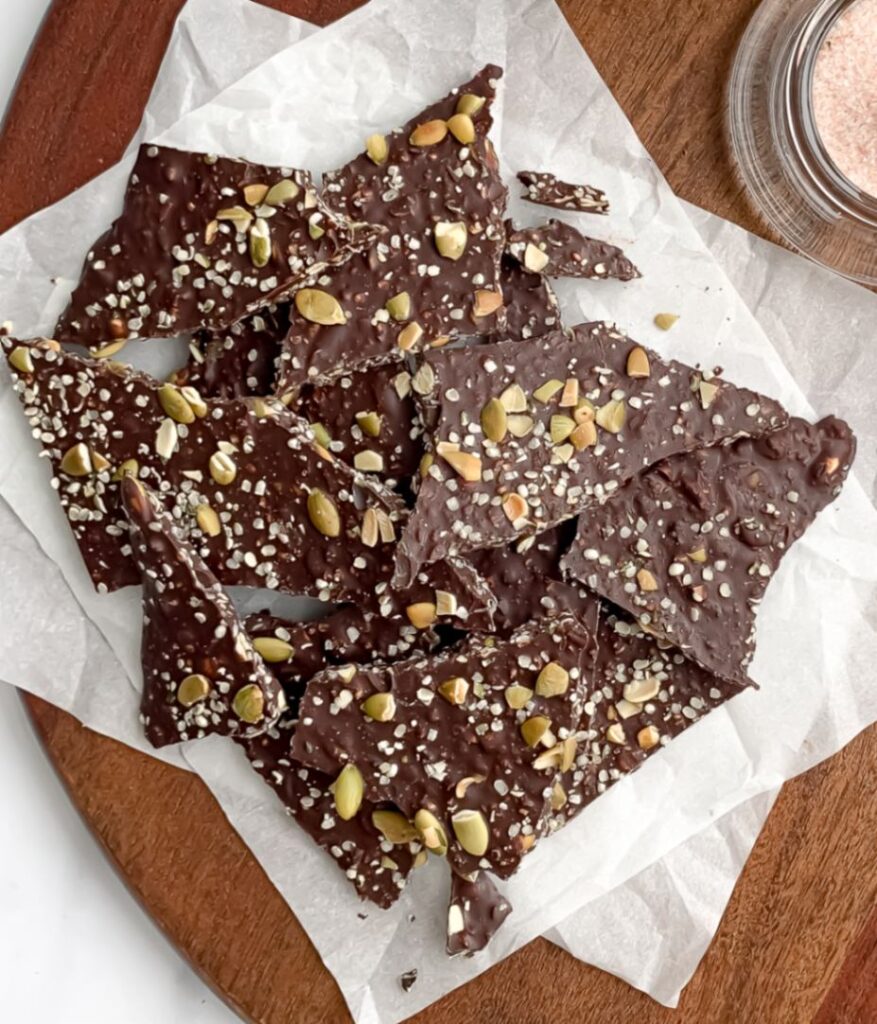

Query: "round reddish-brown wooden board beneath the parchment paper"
left=0, top=0, right=877, bottom=1024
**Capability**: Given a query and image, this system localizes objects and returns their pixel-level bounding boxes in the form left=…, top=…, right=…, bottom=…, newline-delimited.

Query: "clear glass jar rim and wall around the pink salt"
left=727, top=0, right=877, bottom=286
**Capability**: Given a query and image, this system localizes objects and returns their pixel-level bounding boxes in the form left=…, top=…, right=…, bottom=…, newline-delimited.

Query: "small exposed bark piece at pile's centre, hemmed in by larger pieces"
left=293, top=364, right=423, bottom=486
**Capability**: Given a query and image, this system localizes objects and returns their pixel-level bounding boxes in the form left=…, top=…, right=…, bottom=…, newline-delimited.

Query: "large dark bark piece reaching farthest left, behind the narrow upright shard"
left=0, top=338, right=492, bottom=626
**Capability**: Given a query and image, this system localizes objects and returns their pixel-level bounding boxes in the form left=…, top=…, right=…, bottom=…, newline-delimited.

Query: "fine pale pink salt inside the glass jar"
left=812, top=0, right=877, bottom=197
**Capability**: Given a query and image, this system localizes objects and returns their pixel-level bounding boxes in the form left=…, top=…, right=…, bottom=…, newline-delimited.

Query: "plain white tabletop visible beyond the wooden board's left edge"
left=0, top=0, right=238, bottom=1024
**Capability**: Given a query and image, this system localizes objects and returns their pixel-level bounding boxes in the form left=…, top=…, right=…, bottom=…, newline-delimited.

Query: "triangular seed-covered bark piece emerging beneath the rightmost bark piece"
left=551, top=605, right=752, bottom=829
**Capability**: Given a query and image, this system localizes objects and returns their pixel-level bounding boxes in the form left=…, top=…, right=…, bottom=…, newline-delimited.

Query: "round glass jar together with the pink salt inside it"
left=727, top=0, right=877, bottom=286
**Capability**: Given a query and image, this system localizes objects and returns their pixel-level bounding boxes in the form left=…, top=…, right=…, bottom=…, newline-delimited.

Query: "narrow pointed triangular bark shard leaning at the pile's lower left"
left=121, top=476, right=286, bottom=746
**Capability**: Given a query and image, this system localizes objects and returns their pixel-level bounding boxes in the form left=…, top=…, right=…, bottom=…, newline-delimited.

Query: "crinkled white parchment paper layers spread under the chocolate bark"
left=0, top=0, right=877, bottom=1022
